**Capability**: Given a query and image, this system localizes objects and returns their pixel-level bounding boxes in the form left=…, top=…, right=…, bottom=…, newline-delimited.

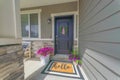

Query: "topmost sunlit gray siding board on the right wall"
left=86, top=50, right=120, bottom=77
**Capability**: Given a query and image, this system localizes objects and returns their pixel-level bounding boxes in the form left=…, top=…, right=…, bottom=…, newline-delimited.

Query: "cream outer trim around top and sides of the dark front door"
left=51, top=11, right=78, bottom=41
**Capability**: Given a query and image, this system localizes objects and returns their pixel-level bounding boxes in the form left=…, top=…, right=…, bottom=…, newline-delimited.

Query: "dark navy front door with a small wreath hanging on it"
left=55, top=16, right=74, bottom=54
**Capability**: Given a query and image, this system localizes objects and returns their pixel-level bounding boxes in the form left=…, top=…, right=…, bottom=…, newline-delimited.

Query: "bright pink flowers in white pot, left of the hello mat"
left=36, top=47, right=54, bottom=65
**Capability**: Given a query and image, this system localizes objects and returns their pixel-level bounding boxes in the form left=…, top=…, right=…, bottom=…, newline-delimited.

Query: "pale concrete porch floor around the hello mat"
left=24, top=55, right=84, bottom=80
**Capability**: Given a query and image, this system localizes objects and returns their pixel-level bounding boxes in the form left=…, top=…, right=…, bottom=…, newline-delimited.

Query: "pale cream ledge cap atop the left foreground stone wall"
left=0, top=38, right=22, bottom=45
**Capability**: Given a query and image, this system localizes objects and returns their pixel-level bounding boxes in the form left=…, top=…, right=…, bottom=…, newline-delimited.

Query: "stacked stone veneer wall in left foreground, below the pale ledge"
left=0, top=45, right=24, bottom=80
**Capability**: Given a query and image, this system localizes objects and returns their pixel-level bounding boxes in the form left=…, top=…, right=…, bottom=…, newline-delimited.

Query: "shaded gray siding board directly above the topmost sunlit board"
left=80, top=41, right=120, bottom=60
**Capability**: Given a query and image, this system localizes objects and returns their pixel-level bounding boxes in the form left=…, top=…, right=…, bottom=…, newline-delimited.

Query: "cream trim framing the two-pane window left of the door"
left=21, top=9, right=42, bottom=40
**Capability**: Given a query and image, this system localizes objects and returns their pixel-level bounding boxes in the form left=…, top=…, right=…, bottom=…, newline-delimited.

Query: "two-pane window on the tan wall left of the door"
left=21, top=11, right=40, bottom=38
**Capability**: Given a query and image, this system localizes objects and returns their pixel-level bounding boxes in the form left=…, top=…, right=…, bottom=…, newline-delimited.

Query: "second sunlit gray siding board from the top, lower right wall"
left=83, top=54, right=119, bottom=80
